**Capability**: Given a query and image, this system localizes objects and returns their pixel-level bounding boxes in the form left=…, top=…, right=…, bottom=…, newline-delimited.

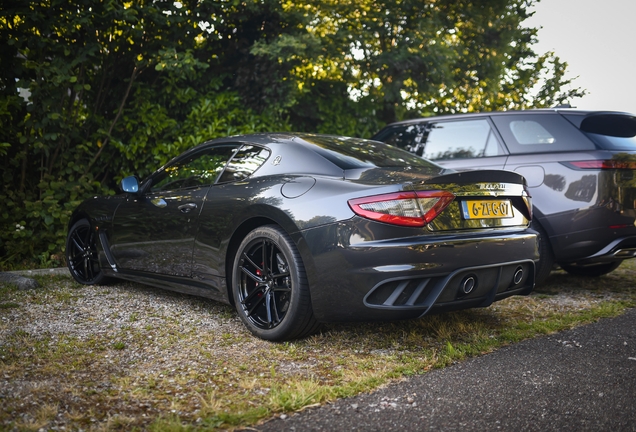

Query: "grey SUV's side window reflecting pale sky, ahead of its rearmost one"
left=422, top=119, right=504, bottom=160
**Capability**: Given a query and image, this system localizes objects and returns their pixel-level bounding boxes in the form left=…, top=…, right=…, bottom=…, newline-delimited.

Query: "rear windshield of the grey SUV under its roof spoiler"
left=564, top=114, right=636, bottom=151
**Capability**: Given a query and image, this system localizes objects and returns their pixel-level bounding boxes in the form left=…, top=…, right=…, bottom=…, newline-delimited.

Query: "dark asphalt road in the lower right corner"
left=251, top=309, right=636, bottom=432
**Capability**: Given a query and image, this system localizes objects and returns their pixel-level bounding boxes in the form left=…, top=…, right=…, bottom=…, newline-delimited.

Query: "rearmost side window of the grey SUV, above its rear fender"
left=492, top=114, right=595, bottom=154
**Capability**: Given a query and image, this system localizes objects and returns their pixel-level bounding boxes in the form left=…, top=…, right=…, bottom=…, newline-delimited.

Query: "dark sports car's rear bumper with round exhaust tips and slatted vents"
left=297, top=221, right=539, bottom=322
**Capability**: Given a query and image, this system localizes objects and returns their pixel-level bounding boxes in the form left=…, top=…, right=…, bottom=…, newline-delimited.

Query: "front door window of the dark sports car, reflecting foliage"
left=150, top=144, right=239, bottom=192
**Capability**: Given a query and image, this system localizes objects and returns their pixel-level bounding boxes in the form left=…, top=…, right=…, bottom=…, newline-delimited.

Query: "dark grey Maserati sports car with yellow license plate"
left=66, top=134, right=539, bottom=340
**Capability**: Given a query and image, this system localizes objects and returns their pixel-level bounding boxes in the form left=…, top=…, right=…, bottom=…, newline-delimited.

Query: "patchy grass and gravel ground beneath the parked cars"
left=0, top=260, right=636, bottom=431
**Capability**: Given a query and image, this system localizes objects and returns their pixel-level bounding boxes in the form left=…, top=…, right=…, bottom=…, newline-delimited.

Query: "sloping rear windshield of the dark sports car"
left=301, top=135, right=439, bottom=170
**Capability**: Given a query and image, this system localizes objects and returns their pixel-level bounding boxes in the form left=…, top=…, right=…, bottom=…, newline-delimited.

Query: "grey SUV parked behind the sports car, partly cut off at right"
left=373, top=109, right=636, bottom=282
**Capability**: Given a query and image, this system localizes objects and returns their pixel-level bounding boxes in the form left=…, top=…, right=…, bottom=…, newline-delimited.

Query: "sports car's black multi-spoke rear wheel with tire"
left=232, top=225, right=318, bottom=341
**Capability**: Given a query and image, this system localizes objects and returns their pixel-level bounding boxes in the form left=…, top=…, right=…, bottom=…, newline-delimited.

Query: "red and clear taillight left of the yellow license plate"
left=349, top=191, right=455, bottom=227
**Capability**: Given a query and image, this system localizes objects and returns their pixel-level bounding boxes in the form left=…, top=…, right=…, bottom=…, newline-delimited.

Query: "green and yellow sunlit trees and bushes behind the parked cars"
left=0, top=0, right=581, bottom=267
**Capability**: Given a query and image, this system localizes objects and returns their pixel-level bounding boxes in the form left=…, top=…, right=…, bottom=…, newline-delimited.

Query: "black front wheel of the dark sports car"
left=66, top=219, right=106, bottom=285
